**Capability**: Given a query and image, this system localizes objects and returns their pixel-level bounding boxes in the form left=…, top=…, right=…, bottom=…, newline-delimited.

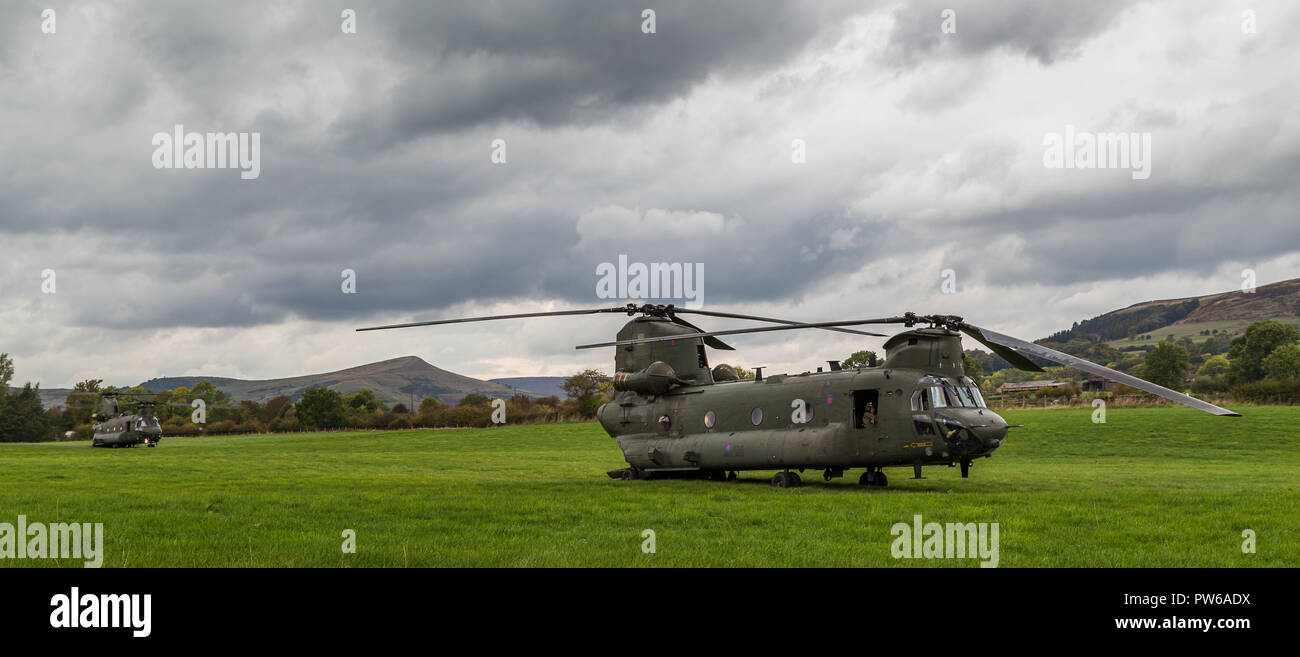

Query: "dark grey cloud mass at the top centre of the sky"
left=339, top=0, right=863, bottom=147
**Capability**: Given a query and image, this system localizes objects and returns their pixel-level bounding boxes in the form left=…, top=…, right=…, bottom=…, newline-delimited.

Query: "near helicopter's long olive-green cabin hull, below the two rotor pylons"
left=598, top=367, right=1006, bottom=474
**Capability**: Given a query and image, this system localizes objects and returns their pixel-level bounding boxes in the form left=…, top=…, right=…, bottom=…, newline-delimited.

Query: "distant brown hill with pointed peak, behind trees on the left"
left=140, top=356, right=514, bottom=405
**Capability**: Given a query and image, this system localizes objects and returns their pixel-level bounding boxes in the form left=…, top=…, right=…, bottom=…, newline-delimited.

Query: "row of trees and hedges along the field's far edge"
left=0, top=320, right=1300, bottom=442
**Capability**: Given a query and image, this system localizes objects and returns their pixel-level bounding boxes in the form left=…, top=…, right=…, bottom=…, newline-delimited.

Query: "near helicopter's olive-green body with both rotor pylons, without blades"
left=597, top=319, right=1008, bottom=477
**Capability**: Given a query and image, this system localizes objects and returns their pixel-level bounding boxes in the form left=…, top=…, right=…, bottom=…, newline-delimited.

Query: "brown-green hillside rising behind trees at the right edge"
left=1045, top=278, right=1300, bottom=347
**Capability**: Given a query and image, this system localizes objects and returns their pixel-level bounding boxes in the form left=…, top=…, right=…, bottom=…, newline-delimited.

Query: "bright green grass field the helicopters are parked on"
left=0, top=407, right=1300, bottom=567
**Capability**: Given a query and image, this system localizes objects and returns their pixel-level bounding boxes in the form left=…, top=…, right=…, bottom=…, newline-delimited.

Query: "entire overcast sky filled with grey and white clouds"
left=0, top=0, right=1300, bottom=388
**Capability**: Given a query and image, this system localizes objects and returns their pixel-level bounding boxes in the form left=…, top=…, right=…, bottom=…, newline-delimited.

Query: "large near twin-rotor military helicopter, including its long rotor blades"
left=358, top=304, right=1238, bottom=488
